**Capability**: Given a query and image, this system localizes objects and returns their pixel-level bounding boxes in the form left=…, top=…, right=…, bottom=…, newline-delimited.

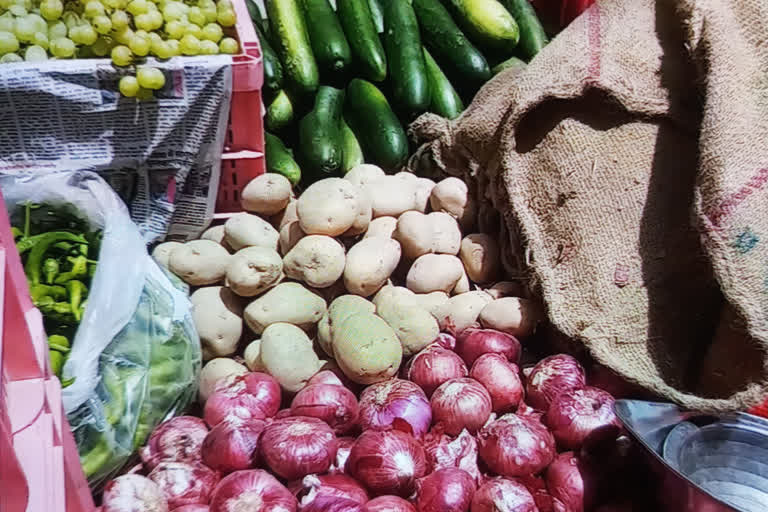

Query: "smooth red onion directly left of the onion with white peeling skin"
left=291, top=382, right=358, bottom=434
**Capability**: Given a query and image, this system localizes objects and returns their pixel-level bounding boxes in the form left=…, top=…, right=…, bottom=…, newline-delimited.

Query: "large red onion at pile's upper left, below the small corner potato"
left=203, top=372, right=280, bottom=427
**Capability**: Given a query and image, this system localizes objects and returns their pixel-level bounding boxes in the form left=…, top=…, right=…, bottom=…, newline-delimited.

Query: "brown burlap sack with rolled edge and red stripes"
left=409, top=0, right=768, bottom=411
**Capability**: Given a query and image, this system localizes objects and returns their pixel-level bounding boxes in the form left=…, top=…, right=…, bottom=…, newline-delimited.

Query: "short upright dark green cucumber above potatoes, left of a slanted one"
left=299, top=85, right=344, bottom=179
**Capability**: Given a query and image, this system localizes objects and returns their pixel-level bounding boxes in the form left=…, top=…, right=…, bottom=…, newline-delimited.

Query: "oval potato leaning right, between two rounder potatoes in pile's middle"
left=344, top=237, right=400, bottom=297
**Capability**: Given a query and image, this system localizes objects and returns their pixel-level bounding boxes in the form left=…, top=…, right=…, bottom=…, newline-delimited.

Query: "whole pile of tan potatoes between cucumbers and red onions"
left=153, top=164, right=539, bottom=400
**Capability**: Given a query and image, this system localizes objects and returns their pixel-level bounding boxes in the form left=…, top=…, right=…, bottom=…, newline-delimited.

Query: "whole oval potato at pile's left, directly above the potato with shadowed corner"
left=168, top=240, right=231, bottom=286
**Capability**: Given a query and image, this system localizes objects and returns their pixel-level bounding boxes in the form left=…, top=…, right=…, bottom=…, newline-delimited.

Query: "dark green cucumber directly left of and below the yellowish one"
left=413, top=0, right=491, bottom=90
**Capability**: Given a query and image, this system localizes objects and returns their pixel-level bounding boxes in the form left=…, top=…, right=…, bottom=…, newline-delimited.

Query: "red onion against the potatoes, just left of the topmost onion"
left=405, top=343, right=468, bottom=396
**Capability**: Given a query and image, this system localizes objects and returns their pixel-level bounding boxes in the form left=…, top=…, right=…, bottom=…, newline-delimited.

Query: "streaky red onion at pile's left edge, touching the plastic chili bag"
left=139, top=416, right=208, bottom=471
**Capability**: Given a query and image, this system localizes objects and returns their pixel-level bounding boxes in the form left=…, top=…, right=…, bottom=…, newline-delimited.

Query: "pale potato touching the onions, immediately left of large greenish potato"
left=259, top=322, right=326, bottom=393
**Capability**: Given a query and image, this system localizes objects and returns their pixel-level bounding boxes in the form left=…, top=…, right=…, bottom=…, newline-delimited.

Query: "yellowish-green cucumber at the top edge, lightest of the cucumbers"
left=445, top=0, right=520, bottom=50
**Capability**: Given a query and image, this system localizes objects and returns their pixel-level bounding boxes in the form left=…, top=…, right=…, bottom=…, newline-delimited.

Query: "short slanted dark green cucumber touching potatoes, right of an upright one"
left=344, top=78, right=408, bottom=170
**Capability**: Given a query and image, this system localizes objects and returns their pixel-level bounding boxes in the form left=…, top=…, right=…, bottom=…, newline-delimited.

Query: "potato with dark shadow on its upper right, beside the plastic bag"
left=189, top=286, right=243, bottom=359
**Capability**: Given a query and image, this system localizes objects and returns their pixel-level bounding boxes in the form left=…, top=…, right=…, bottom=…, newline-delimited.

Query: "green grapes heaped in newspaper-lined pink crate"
left=0, top=0, right=239, bottom=98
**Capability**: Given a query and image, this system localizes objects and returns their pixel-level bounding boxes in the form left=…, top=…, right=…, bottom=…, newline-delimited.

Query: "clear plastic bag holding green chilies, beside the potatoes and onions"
left=0, top=171, right=201, bottom=487
